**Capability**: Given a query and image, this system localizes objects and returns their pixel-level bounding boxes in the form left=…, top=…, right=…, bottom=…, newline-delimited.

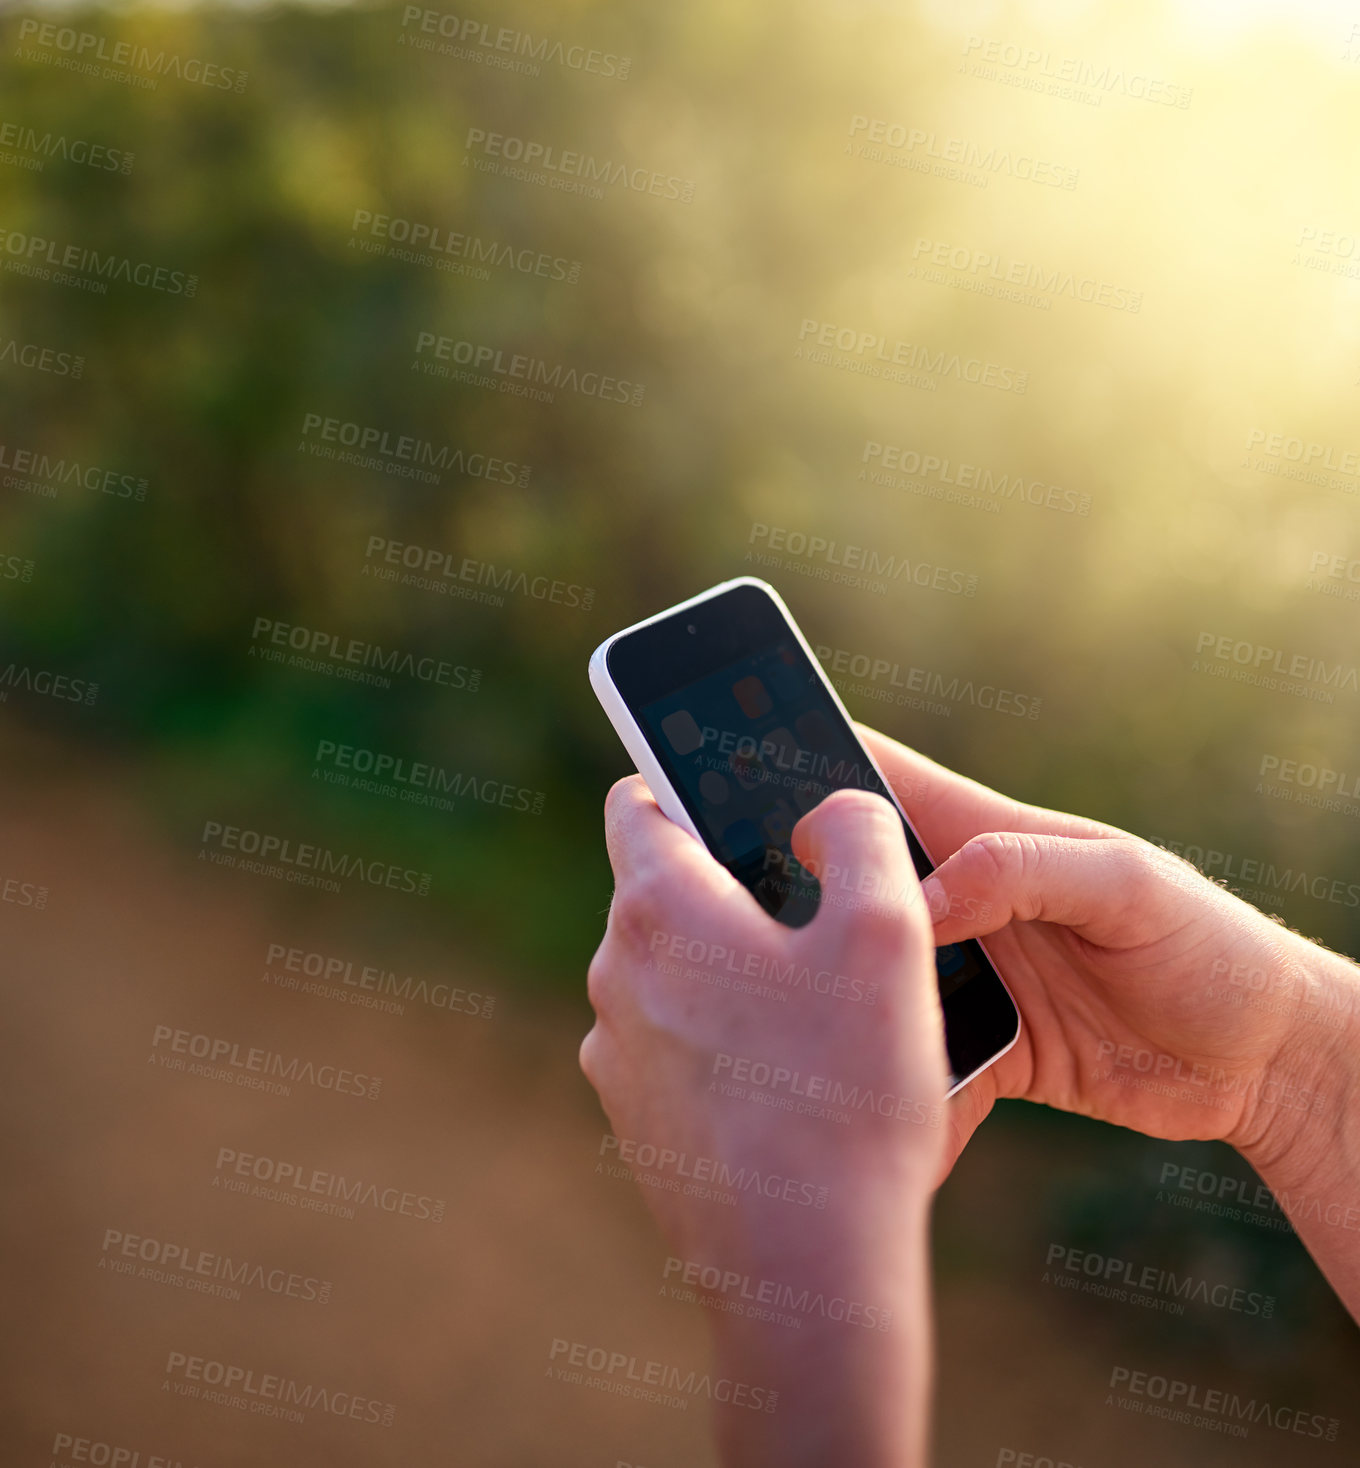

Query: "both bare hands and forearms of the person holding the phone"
left=582, top=728, right=1360, bottom=1468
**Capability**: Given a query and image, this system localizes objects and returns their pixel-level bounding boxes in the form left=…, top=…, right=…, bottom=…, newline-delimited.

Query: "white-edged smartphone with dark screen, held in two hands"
left=590, top=577, right=1019, bottom=1095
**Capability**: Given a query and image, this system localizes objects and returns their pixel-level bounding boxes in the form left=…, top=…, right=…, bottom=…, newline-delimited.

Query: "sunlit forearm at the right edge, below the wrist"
left=1243, top=944, right=1360, bottom=1323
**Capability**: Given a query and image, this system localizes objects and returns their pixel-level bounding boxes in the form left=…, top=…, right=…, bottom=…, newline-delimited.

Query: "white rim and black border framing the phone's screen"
left=590, top=575, right=1022, bottom=1095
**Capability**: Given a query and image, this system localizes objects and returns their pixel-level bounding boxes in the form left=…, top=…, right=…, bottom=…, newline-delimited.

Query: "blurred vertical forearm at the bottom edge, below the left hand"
left=702, top=1189, right=933, bottom=1468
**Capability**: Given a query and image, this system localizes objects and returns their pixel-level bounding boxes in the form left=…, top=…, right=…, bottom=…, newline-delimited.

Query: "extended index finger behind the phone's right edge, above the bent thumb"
left=855, top=722, right=1124, bottom=863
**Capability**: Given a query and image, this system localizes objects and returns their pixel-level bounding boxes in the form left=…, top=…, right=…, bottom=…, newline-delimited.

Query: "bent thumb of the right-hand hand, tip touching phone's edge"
left=922, top=831, right=1147, bottom=947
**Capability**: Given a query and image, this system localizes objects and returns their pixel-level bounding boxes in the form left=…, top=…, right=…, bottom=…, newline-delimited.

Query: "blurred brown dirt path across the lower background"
left=0, top=740, right=1360, bottom=1468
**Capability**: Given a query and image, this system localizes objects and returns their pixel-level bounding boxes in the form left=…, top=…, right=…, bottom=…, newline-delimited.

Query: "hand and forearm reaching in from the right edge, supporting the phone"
left=859, top=727, right=1360, bottom=1318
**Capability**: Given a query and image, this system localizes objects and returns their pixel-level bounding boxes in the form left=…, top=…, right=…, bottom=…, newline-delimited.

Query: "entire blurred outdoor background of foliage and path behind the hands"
left=0, top=0, right=1360, bottom=1468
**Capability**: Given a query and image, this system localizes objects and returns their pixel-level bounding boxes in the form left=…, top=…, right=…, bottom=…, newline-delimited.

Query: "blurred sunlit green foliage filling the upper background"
left=0, top=0, right=1360, bottom=988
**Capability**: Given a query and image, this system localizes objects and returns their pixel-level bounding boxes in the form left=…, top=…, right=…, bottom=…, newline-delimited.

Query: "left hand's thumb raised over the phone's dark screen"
left=793, top=790, right=934, bottom=948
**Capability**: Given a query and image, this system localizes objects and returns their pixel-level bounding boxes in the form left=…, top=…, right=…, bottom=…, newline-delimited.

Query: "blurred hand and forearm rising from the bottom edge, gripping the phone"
left=582, top=777, right=946, bottom=1468
